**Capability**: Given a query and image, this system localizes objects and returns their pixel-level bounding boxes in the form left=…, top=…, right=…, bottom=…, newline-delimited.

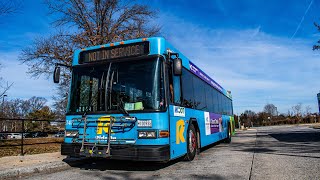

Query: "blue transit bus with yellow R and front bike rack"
left=53, top=37, right=234, bottom=162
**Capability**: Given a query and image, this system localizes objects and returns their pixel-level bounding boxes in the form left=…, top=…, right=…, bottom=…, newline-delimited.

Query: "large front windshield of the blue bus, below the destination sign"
left=68, top=58, right=165, bottom=113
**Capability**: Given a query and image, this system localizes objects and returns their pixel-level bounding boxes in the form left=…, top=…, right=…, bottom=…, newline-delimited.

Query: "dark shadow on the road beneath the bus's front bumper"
left=64, top=158, right=183, bottom=171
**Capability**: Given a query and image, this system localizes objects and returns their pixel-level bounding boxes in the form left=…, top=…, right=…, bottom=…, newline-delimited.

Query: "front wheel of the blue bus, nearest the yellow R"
left=184, top=124, right=198, bottom=161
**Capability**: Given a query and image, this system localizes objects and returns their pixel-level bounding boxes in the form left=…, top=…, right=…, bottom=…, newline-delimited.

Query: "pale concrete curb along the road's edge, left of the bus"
left=0, top=159, right=83, bottom=179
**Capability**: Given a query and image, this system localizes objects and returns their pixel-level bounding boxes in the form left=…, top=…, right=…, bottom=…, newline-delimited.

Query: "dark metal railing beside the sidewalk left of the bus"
left=0, top=117, right=65, bottom=156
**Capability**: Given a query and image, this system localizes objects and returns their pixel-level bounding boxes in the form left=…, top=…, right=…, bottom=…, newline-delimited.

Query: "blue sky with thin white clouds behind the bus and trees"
left=0, top=0, right=320, bottom=113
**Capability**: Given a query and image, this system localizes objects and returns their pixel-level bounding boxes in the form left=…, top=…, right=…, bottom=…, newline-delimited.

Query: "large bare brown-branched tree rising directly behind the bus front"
left=19, top=0, right=160, bottom=114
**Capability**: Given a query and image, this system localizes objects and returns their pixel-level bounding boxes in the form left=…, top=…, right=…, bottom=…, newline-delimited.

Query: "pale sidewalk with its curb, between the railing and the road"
left=0, top=152, right=79, bottom=179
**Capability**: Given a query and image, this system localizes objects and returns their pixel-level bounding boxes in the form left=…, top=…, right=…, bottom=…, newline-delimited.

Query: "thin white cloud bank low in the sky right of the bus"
left=161, top=14, right=320, bottom=113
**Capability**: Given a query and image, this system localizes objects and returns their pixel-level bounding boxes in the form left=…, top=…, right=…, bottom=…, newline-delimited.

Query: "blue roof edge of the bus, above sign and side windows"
left=72, top=37, right=232, bottom=99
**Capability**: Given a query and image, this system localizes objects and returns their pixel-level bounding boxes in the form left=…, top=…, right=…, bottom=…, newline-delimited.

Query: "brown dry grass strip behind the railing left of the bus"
left=0, top=138, right=63, bottom=157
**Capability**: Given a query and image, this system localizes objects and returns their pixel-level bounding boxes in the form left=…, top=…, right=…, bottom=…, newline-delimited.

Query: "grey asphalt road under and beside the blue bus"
left=23, top=125, right=320, bottom=180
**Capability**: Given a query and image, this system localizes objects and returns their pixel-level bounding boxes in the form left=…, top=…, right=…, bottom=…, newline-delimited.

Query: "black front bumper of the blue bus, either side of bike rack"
left=61, top=143, right=170, bottom=161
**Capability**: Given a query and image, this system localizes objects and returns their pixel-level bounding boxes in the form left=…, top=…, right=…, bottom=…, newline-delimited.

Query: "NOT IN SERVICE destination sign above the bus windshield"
left=79, top=42, right=149, bottom=64
